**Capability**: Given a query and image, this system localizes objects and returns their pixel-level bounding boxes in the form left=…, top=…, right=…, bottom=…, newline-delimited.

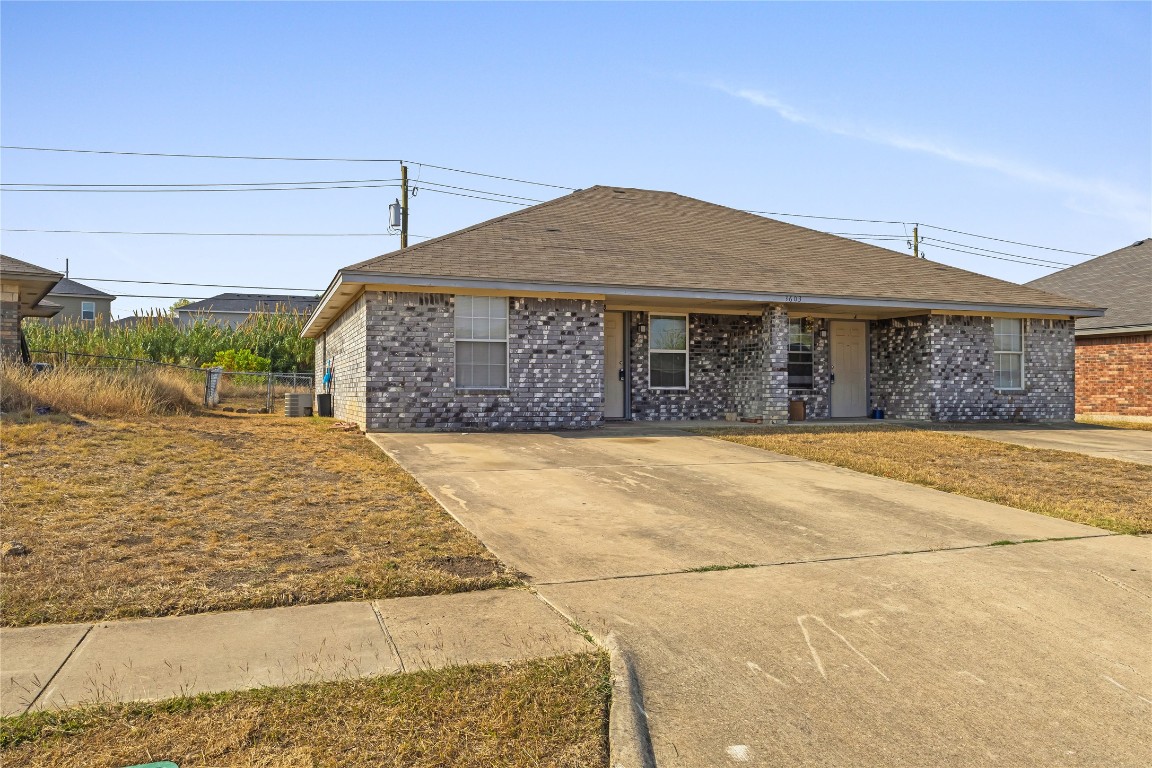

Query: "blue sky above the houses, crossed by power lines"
left=0, top=2, right=1152, bottom=315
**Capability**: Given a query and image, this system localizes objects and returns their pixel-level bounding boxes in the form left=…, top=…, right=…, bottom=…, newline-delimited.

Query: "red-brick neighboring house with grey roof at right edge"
left=1028, top=238, right=1152, bottom=416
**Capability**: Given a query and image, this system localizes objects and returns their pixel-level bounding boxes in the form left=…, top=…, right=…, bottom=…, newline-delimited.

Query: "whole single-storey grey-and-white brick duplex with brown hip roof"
left=304, top=187, right=1102, bottom=431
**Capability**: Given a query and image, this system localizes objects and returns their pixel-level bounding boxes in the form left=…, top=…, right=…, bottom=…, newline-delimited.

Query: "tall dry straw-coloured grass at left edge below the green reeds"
left=0, top=364, right=204, bottom=421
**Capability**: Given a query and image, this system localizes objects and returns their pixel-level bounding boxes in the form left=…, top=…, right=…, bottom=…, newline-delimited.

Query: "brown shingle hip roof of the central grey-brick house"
left=346, top=187, right=1096, bottom=309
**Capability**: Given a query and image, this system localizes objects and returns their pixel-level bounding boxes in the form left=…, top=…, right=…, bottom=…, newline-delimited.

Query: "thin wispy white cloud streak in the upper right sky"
left=712, top=83, right=1152, bottom=226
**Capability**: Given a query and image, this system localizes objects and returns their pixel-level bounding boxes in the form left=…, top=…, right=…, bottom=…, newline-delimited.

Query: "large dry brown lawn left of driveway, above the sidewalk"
left=0, top=415, right=517, bottom=626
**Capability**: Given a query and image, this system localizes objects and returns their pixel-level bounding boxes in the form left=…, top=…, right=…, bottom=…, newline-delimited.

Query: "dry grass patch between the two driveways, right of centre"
left=706, top=426, right=1152, bottom=533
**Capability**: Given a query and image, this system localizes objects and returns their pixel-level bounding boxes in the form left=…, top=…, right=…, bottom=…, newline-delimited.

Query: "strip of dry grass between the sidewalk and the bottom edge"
left=0, top=654, right=611, bottom=768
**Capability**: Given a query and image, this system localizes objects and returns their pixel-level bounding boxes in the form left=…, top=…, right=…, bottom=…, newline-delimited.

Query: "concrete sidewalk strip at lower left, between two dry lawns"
left=0, top=590, right=594, bottom=716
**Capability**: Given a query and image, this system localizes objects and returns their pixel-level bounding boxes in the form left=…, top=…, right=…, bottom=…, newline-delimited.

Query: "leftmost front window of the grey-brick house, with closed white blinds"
left=456, top=296, right=508, bottom=389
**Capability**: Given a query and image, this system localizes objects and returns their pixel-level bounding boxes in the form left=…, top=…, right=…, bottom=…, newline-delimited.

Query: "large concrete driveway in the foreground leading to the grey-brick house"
left=372, top=428, right=1152, bottom=767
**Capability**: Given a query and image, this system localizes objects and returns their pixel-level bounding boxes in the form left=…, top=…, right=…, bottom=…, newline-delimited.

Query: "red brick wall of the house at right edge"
left=1076, top=334, right=1152, bottom=416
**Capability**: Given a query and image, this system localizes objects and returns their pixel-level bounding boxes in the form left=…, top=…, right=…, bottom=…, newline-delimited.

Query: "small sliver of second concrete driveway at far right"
left=927, top=424, right=1152, bottom=464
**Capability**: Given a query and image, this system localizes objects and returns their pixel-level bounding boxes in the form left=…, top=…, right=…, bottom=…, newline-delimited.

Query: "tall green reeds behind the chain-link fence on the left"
left=24, top=312, right=314, bottom=372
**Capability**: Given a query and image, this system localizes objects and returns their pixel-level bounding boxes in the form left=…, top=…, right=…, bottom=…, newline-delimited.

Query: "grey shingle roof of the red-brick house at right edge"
left=1028, top=237, right=1152, bottom=333
